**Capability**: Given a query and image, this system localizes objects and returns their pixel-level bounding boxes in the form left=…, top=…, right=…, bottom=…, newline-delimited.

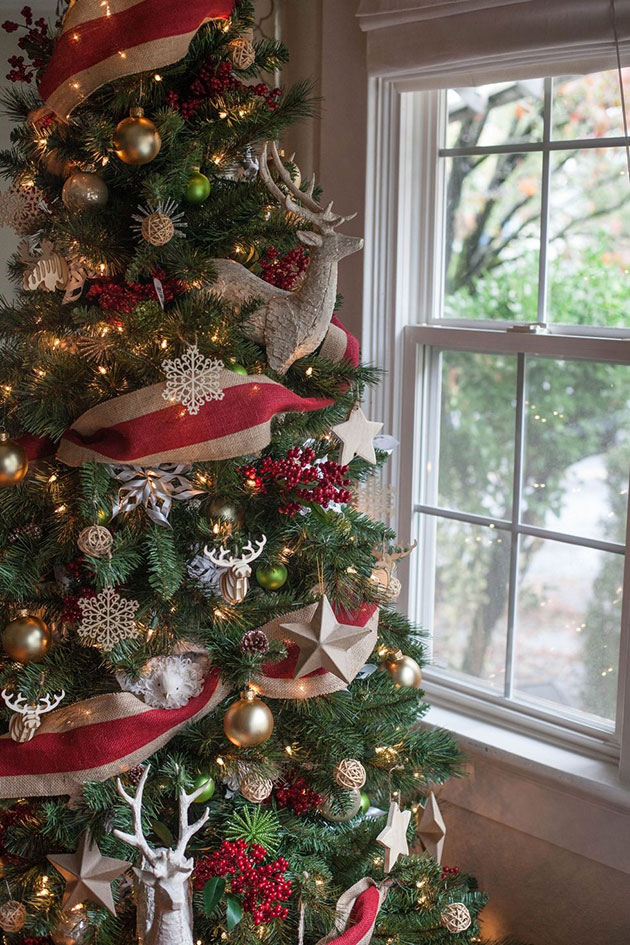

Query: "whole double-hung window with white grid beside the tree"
left=373, top=70, right=630, bottom=757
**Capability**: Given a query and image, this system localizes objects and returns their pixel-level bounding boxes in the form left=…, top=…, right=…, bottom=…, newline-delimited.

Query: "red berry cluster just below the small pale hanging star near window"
left=242, top=446, right=352, bottom=516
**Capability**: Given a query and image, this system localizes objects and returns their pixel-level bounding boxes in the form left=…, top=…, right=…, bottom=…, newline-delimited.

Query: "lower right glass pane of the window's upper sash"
left=548, top=148, right=630, bottom=327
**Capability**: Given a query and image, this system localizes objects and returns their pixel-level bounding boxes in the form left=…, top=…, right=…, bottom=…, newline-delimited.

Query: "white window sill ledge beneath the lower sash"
left=424, top=705, right=630, bottom=812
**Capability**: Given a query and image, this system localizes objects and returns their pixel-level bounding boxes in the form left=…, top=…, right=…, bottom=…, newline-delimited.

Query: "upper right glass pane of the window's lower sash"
left=522, top=358, right=630, bottom=544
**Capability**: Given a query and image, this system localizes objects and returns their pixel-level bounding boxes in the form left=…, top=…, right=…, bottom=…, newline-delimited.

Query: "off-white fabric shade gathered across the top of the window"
left=357, top=0, right=630, bottom=88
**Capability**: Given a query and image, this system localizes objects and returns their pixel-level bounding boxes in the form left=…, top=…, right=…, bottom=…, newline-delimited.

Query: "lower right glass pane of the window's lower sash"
left=514, top=538, right=624, bottom=721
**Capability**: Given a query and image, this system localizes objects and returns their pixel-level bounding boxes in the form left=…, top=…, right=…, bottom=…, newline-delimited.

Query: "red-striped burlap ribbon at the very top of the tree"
left=39, top=0, right=234, bottom=118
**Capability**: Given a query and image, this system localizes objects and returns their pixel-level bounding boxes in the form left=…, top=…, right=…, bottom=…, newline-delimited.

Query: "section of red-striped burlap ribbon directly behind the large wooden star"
left=253, top=604, right=379, bottom=699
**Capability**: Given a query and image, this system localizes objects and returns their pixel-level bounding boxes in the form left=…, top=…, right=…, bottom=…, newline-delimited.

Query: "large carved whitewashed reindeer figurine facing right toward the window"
left=214, top=143, right=363, bottom=374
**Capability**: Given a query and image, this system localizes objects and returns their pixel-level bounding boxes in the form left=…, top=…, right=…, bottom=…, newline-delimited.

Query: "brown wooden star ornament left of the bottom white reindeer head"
left=48, top=833, right=132, bottom=915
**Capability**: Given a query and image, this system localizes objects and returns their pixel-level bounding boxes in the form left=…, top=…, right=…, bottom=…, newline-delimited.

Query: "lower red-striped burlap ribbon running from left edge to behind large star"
left=0, top=605, right=378, bottom=798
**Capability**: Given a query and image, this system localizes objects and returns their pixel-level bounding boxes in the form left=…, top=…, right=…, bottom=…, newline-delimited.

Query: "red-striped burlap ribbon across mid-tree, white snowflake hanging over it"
left=53, top=321, right=359, bottom=466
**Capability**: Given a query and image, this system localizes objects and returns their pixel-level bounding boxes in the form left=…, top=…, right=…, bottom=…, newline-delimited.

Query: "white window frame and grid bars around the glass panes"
left=363, top=75, right=630, bottom=784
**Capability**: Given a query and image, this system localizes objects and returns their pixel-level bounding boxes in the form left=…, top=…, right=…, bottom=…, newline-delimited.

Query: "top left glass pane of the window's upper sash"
left=446, top=79, right=544, bottom=148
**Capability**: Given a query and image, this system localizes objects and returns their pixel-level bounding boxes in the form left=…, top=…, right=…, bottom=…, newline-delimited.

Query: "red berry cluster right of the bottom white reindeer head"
left=193, top=840, right=293, bottom=925
